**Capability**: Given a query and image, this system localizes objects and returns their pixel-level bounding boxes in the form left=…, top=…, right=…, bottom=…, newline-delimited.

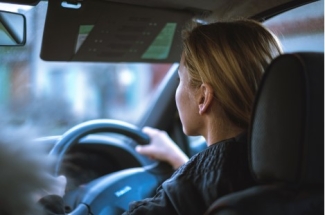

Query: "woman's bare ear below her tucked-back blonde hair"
left=198, top=83, right=213, bottom=115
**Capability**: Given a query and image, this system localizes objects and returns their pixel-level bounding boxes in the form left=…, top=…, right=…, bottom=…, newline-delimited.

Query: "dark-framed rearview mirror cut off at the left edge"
left=0, top=11, right=26, bottom=46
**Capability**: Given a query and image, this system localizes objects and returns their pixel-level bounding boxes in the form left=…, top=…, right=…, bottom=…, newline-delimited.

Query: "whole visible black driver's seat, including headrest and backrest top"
left=205, top=53, right=324, bottom=215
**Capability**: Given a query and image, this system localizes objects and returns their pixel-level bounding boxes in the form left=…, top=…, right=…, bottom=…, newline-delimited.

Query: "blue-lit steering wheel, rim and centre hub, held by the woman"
left=50, top=119, right=173, bottom=215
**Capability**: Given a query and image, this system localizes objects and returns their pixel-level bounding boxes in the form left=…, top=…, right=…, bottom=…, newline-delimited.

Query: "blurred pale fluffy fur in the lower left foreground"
left=0, top=125, right=59, bottom=215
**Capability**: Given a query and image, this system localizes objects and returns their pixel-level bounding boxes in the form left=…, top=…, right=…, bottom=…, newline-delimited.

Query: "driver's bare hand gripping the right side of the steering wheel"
left=135, top=127, right=188, bottom=169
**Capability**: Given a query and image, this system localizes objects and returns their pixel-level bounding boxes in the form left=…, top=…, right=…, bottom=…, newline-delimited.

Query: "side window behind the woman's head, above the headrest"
left=264, top=0, right=324, bottom=52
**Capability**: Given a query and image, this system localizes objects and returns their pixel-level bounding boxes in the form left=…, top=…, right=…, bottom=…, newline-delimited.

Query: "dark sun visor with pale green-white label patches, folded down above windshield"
left=41, top=0, right=193, bottom=63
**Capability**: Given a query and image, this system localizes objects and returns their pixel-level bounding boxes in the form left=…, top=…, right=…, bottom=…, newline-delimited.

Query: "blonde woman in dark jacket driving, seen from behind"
left=124, top=20, right=281, bottom=215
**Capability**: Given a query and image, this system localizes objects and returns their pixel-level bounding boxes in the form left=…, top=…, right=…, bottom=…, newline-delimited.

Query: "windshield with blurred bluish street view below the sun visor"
left=0, top=1, right=172, bottom=135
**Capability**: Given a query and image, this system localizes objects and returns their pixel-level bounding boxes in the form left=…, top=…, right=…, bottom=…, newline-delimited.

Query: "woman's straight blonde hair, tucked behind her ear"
left=182, top=19, right=282, bottom=129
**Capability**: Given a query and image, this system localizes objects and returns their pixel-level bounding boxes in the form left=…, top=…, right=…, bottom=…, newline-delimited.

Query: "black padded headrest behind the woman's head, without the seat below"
left=249, top=53, right=324, bottom=184
